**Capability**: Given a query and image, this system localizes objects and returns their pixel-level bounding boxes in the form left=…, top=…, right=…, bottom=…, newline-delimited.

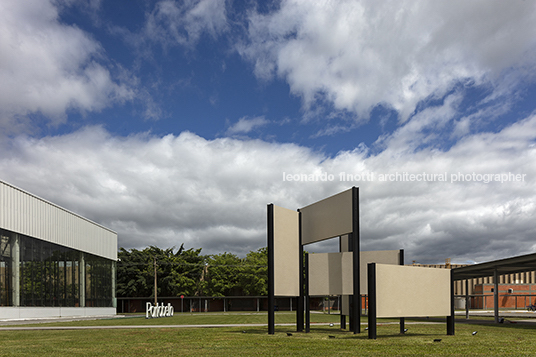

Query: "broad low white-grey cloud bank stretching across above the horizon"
left=0, top=115, right=536, bottom=262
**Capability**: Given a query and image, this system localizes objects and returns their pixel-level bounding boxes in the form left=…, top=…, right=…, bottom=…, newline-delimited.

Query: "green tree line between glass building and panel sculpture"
left=116, top=244, right=268, bottom=297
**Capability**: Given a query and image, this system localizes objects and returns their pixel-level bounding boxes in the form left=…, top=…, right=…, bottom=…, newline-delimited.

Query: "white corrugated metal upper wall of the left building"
left=0, top=181, right=117, bottom=260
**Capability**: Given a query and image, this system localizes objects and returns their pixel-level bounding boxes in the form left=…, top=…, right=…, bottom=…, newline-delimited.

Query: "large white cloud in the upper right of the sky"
left=238, top=0, right=536, bottom=121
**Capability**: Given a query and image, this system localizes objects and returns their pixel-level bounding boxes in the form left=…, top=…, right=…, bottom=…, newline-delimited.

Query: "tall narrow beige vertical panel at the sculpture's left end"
left=273, top=205, right=300, bottom=296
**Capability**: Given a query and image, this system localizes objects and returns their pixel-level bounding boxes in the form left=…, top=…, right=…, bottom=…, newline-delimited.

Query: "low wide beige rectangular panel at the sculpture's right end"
left=376, top=264, right=450, bottom=317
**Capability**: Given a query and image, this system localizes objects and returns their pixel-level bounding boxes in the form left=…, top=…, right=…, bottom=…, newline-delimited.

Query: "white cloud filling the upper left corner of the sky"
left=0, top=0, right=133, bottom=134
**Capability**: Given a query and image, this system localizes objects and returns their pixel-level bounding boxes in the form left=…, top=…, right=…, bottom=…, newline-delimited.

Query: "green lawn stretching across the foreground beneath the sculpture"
left=0, top=312, right=536, bottom=357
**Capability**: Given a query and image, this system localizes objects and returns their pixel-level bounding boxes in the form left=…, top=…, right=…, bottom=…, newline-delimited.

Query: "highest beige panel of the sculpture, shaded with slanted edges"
left=300, top=189, right=353, bottom=244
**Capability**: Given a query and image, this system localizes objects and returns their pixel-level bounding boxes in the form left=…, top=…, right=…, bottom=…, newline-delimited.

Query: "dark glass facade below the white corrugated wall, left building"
left=0, top=229, right=115, bottom=307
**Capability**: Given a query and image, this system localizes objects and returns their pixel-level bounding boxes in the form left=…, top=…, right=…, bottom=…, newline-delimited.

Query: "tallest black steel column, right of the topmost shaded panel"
left=348, top=187, right=361, bottom=334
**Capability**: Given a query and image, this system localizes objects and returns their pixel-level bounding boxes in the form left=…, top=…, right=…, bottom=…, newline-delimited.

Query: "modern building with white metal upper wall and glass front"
left=0, top=181, right=117, bottom=319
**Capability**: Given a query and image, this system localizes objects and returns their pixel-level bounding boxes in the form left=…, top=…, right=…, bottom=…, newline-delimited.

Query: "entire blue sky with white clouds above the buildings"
left=0, top=0, right=536, bottom=263
